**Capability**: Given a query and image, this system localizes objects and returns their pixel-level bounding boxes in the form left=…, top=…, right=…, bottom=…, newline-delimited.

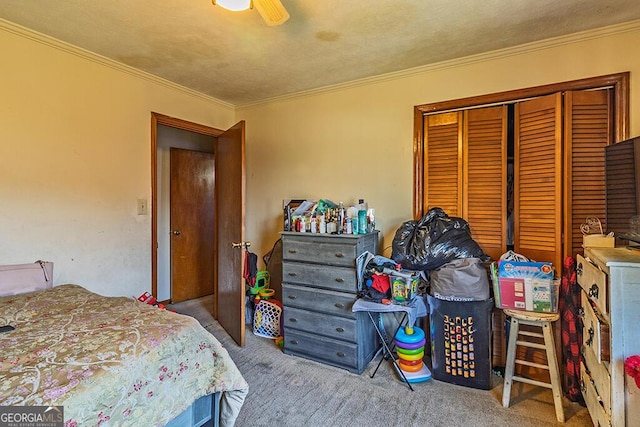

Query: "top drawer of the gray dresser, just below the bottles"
left=282, top=236, right=359, bottom=268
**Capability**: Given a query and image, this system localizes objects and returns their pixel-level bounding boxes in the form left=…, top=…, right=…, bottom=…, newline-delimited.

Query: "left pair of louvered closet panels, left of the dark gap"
left=423, top=105, right=508, bottom=259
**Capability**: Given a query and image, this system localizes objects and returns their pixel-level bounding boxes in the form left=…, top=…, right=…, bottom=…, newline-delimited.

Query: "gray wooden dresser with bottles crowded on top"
left=282, top=231, right=378, bottom=374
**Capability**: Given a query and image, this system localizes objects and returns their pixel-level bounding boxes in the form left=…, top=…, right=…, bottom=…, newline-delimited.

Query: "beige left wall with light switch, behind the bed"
left=0, top=23, right=234, bottom=296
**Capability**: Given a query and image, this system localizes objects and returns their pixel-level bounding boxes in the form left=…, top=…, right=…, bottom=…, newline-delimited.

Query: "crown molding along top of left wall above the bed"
left=0, top=18, right=235, bottom=110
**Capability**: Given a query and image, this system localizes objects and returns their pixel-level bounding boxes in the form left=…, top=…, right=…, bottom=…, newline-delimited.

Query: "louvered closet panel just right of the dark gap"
left=514, top=93, right=562, bottom=271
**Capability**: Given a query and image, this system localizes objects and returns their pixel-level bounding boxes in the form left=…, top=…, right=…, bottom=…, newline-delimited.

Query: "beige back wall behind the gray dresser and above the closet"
left=237, top=22, right=640, bottom=256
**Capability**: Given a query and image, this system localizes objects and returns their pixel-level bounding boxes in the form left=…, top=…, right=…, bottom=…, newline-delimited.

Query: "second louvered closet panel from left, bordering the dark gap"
left=462, top=105, right=508, bottom=259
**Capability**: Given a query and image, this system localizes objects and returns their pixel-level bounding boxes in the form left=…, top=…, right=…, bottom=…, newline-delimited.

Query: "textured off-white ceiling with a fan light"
left=0, top=0, right=640, bottom=105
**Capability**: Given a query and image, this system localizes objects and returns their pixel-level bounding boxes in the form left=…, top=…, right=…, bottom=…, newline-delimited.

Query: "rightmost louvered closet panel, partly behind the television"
left=564, top=89, right=613, bottom=257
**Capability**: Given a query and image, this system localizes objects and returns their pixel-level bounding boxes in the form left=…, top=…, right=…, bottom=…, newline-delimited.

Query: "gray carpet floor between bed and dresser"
left=171, top=298, right=592, bottom=427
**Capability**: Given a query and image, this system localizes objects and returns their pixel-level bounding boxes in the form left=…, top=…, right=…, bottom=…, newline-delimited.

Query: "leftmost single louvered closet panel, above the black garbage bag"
left=422, top=112, right=462, bottom=216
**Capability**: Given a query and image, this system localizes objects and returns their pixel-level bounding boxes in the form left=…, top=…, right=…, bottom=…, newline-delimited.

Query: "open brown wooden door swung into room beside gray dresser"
left=214, top=121, right=245, bottom=346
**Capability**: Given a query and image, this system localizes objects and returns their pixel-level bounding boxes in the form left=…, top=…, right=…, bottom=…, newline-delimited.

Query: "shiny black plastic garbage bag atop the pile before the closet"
left=391, top=208, right=490, bottom=271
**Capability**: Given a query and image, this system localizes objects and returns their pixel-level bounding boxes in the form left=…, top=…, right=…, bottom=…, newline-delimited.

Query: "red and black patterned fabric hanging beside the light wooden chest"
left=558, top=257, right=584, bottom=402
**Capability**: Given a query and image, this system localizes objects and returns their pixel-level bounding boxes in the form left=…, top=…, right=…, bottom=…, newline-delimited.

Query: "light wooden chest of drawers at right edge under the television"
left=576, top=248, right=640, bottom=427
